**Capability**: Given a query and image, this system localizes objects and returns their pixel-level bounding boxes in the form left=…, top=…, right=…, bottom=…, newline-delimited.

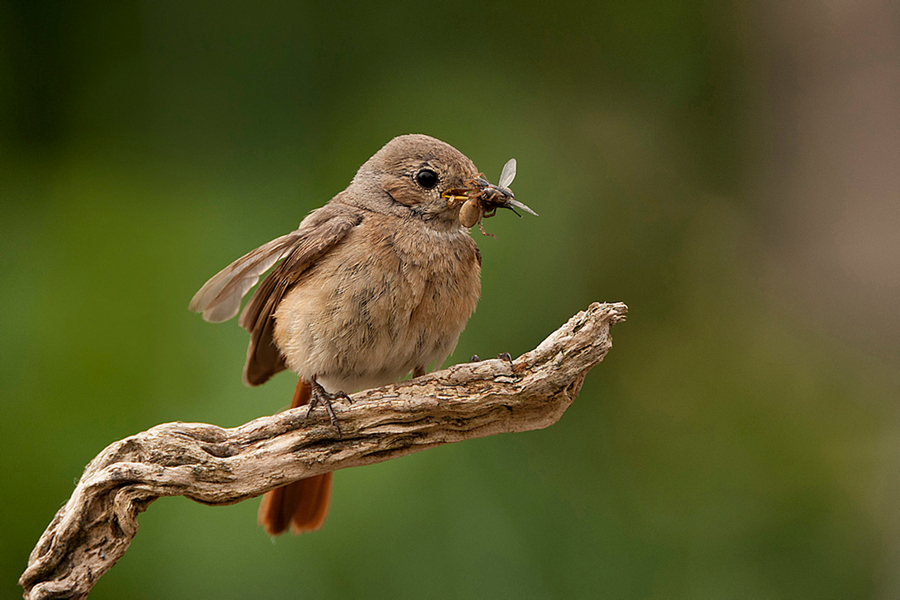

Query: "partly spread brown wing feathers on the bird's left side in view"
left=190, top=211, right=362, bottom=385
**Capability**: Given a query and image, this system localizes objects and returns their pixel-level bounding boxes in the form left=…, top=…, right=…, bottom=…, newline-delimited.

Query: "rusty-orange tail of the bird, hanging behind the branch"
left=259, top=378, right=331, bottom=535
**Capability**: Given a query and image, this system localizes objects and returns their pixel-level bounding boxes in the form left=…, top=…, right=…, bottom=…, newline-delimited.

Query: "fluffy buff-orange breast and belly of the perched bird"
left=274, top=215, right=481, bottom=391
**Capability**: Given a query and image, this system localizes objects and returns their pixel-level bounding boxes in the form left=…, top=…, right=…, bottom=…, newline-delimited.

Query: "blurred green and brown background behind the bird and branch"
left=0, top=0, right=900, bottom=599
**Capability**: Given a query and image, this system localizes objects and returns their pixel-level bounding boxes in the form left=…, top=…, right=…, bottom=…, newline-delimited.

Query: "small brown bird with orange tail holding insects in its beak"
left=190, top=135, right=532, bottom=535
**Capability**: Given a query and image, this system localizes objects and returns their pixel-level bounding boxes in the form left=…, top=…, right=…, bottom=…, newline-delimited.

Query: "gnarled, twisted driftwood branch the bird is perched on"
left=19, top=303, right=627, bottom=599
